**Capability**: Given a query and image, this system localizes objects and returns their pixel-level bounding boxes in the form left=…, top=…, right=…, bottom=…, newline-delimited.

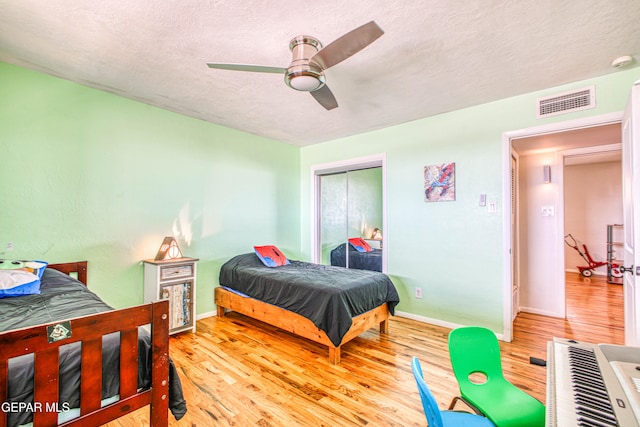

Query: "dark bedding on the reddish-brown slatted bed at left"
left=0, top=268, right=187, bottom=426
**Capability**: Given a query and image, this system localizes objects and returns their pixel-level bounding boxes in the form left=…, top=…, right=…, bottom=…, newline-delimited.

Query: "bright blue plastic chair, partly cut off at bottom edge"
left=411, top=357, right=495, bottom=427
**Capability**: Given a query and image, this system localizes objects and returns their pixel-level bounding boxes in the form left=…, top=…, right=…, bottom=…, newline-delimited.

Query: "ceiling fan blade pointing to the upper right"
left=311, top=21, right=384, bottom=70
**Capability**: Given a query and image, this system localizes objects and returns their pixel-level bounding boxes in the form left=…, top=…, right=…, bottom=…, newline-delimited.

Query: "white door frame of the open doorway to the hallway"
left=502, top=111, right=623, bottom=342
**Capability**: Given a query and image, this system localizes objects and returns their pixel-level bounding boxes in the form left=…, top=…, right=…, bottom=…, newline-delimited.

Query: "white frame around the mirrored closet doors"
left=310, top=153, right=389, bottom=272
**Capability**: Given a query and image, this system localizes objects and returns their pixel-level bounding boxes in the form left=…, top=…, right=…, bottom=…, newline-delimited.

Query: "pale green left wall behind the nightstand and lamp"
left=0, top=63, right=300, bottom=313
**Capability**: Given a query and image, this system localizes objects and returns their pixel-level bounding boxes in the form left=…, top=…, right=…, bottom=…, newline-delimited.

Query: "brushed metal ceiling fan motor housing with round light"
left=284, top=36, right=325, bottom=92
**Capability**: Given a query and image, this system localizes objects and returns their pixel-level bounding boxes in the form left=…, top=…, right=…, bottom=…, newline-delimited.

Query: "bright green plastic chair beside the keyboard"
left=449, top=326, right=545, bottom=427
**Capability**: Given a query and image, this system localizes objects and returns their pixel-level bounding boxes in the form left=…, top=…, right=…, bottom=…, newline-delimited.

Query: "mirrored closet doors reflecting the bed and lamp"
left=320, top=167, right=384, bottom=271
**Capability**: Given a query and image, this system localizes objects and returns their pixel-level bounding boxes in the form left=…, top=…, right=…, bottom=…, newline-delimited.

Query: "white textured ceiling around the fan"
left=0, top=0, right=640, bottom=146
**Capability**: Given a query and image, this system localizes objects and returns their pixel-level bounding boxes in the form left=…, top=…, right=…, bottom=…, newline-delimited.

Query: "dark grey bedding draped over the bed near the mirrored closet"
left=220, top=253, right=400, bottom=346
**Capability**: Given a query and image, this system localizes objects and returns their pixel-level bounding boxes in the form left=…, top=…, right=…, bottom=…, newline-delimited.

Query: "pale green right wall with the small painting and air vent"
left=300, top=68, right=640, bottom=332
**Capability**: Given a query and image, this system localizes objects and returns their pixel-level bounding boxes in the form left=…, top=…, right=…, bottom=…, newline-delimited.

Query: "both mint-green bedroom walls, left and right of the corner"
left=0, top=59, right=640, bottom=332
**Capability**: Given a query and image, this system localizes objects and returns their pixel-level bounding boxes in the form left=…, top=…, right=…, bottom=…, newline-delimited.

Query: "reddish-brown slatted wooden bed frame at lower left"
left=0, top=261, right=169, bottom=427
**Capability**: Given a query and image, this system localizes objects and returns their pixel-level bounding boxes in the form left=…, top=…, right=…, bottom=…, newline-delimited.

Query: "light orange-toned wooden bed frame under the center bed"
left=214, top=287, right=389, bottom=365
